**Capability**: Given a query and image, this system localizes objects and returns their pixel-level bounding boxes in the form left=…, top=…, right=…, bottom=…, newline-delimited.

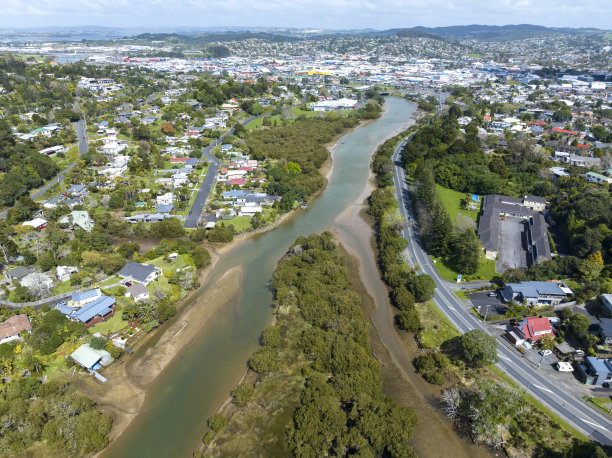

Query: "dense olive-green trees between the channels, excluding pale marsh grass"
left=237, top=232, right=418, bottom=456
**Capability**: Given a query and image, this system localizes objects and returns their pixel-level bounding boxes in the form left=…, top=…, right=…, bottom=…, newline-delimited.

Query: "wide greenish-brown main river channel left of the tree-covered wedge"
left=104, top=97, right=416, bottom=458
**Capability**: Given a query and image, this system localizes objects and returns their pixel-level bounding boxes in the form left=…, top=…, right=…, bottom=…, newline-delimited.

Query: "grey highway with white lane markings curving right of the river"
left=393, top=139, right=612, bottom=445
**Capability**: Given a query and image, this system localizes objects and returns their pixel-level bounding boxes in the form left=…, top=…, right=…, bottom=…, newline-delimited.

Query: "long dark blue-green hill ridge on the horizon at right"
left=396, top=24, right=604, bottom=41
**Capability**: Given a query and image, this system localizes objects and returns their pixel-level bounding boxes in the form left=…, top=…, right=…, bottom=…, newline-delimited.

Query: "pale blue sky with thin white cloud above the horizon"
left=0, top=0, right=612, bottom=30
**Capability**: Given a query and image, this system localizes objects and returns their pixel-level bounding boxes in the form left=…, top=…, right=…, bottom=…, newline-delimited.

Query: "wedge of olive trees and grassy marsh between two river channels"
left=203, top=232, right=418, bottom=456
